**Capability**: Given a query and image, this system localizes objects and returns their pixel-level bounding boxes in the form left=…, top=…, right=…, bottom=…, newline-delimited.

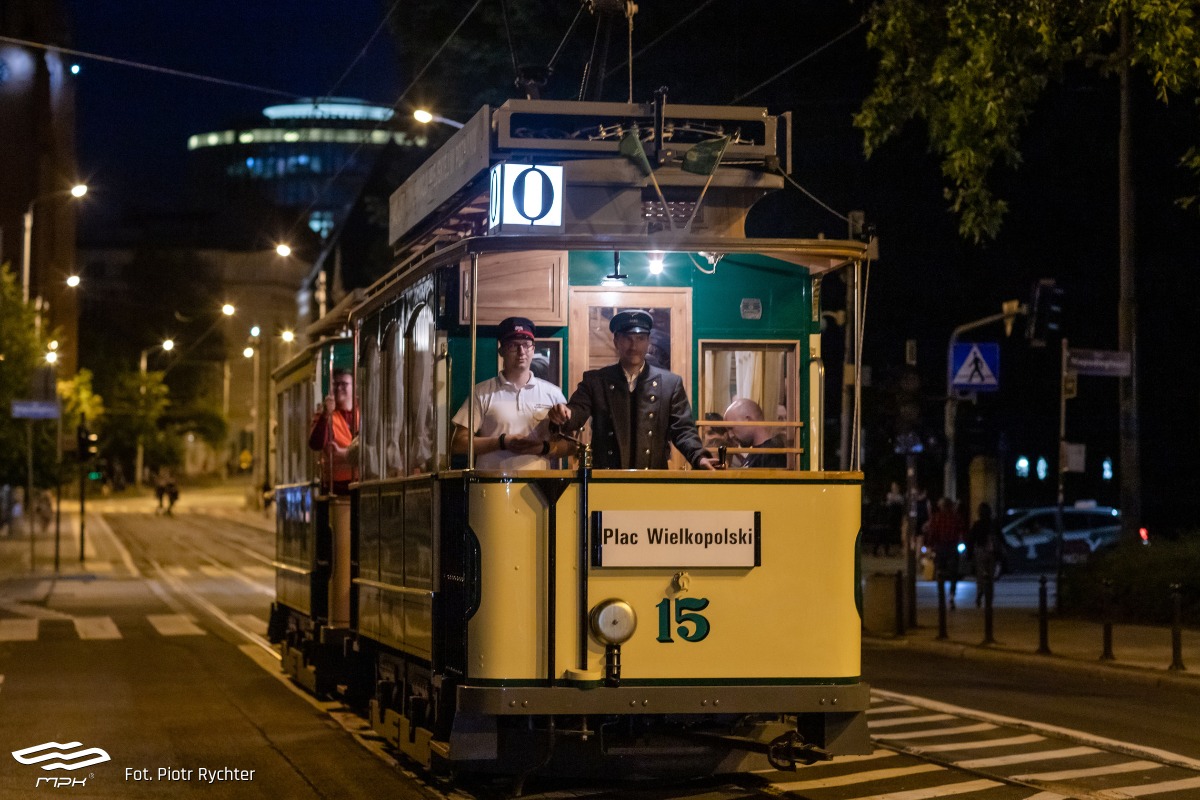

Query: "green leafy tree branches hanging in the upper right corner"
left=854, top=0, right=1200, bottom=241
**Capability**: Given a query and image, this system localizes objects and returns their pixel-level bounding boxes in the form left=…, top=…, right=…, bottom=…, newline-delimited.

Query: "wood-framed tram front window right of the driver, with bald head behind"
left=697, top=341, right=802, bottom=469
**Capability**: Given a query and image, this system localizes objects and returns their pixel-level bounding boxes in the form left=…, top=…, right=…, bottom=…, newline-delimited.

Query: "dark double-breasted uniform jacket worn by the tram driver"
left=564, top=363, right=712, bottom=469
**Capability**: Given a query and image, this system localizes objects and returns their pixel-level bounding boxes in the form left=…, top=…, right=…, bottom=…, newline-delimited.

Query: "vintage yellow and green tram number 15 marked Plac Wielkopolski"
left=271, top=98, right=869, bottom=775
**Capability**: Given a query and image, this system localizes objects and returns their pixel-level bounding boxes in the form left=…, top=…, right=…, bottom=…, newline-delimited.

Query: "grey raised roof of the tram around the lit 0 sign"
left=389, top=100, right=858, bottom=271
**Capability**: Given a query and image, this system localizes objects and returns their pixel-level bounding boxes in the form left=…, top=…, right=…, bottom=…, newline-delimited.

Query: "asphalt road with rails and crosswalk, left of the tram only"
left=0, top=515, right=436, bottom=799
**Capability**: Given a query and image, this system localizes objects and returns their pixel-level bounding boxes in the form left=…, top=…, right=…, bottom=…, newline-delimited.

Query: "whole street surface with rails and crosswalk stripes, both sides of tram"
left=0, top=501, right=1200, bottom=800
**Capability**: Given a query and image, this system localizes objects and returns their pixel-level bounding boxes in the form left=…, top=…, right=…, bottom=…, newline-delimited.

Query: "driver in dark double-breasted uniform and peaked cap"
left=548, top=311, right=716, bottom=469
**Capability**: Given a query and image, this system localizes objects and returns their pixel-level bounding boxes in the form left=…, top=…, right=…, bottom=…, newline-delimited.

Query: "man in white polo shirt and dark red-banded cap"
left=451, top=317, right=571, bottom=470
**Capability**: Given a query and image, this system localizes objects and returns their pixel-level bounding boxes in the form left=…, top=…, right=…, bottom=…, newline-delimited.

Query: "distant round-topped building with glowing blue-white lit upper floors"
left=187, top=97, right=426, bottom=240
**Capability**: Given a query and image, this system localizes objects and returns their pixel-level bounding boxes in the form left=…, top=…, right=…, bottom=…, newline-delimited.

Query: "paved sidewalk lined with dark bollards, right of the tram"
left=863, top=554, right=1200, bottom=691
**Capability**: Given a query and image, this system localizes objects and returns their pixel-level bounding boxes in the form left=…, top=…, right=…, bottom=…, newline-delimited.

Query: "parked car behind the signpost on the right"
left=1000, top=504, right=1121, bottom=572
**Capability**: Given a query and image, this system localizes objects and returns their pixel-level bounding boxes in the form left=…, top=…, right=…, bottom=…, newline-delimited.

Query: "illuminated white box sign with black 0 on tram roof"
left=487, top=163, right=563, bottom=234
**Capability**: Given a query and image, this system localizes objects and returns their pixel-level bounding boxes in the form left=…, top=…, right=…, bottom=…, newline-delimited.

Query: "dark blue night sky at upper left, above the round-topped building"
left=66, top=0, right=401, bottom=223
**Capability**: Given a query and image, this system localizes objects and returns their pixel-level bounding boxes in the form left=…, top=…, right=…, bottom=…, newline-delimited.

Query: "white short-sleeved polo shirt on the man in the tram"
left=454, top=375, right=566, bottom=470
